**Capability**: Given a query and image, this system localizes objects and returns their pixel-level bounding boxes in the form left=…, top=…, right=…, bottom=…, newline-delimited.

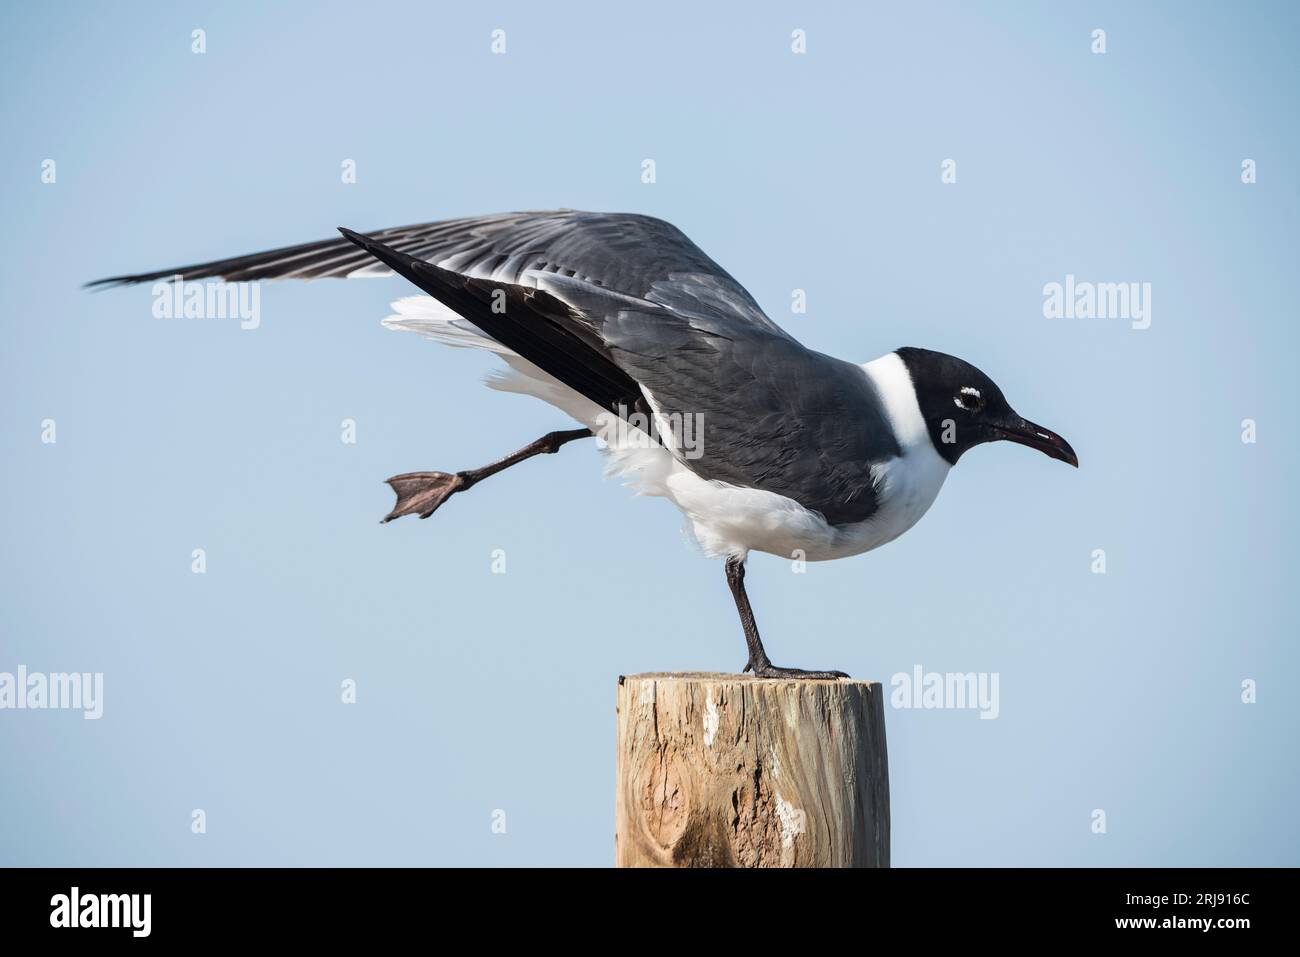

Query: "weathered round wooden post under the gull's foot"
left=615, top=672, right=889, bottom=867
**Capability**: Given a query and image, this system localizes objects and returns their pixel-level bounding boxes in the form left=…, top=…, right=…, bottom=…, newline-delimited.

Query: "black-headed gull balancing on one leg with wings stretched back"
left=90, top=209, right=1079, bottom=679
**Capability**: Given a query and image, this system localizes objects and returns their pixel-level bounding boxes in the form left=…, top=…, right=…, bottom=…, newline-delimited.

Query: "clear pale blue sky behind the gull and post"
left=0, top=3, right=1300, bottom=865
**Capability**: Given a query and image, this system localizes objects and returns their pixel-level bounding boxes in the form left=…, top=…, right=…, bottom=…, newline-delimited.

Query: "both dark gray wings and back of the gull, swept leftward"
left=91, top=211, right=897, bottom=524
